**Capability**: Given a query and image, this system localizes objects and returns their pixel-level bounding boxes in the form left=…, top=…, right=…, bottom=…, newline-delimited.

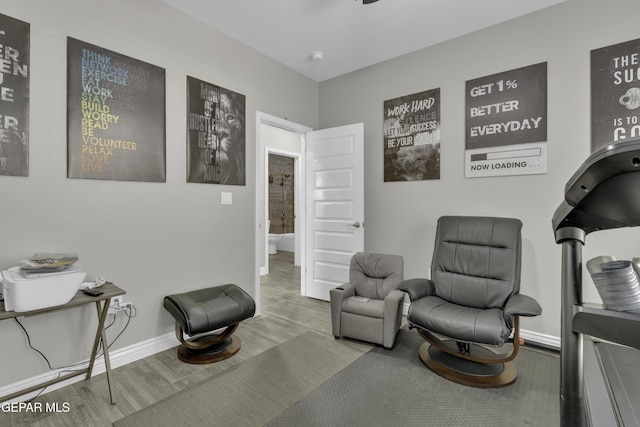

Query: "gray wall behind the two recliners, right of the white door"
left=320, top=0, right=640, bottom=344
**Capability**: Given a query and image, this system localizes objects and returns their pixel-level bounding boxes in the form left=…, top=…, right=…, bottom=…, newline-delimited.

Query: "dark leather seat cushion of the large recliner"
left=407, top=296, right=511, bottom=346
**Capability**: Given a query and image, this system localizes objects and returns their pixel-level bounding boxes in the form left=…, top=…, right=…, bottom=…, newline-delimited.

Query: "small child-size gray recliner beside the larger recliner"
left=329, top=252, right=405, bottom=348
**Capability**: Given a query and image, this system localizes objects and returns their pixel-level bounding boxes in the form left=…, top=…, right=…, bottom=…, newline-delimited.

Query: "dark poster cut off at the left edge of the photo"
left=0, top=14, right=30, bottom=176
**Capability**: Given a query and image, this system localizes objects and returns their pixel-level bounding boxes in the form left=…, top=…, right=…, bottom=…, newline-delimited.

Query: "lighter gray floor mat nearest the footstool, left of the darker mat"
left=113, top=332, right=365, bottom=427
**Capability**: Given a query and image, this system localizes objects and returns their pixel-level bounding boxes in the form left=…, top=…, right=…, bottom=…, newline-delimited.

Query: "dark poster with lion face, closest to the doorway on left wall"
left=187, top=76, right=246, bottom=185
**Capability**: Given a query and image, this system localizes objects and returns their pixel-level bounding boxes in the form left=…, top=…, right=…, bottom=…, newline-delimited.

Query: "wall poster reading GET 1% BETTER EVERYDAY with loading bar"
left=465, top=62, right=547, bottom=178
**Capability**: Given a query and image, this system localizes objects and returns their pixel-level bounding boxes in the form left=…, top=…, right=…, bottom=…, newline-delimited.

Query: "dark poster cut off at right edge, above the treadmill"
left=591, top=39, right=640, bottom=151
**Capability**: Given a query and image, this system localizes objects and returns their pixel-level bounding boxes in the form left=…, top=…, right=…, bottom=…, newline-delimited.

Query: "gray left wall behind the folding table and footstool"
left=0, top=0, right=319, bottom=386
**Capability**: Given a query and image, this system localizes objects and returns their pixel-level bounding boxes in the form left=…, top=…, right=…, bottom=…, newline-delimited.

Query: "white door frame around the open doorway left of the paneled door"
left=254, top=112, right=311, bottom=314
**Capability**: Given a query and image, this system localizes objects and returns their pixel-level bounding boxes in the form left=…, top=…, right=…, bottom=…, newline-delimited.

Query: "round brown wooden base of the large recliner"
left=419, top=341, right=518, bottom=388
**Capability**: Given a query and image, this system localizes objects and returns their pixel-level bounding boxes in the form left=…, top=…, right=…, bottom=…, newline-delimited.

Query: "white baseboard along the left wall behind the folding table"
left=0, top=333, right=178, bottom=402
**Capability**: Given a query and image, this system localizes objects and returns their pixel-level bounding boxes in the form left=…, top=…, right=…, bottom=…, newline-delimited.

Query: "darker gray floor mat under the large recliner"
left=268, top=329, right=560, bottom=427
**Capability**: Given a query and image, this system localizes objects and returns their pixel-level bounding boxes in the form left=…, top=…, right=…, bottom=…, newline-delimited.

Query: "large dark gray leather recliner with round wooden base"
left=400, top=216, right=542, bottom=387
